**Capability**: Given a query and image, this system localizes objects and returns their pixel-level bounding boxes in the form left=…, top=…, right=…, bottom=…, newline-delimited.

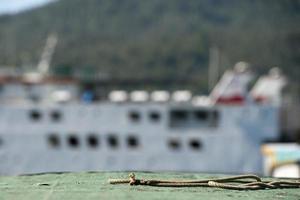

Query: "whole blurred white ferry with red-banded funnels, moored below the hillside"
left=0, top=59, right=286, bottom=175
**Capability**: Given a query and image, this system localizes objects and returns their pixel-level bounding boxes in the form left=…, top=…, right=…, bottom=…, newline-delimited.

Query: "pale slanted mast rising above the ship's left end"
left=37, top=33, right=58, bottom=75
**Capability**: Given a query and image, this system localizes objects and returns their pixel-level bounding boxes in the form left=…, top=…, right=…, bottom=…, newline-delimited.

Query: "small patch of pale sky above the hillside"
left=0, top=0, right=52, bottom=14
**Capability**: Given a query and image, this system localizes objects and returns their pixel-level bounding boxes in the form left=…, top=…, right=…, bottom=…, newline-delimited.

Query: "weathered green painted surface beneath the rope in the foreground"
left=0, top=172, right=300, bottom=200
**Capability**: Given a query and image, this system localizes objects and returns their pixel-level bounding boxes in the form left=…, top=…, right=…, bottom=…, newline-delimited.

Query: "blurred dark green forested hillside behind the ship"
left=0, top=0, right=300, bottom=91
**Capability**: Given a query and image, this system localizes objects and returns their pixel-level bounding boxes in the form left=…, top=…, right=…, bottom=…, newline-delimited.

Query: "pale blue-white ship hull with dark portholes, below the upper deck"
left=0, top=102, right=279, bottom=174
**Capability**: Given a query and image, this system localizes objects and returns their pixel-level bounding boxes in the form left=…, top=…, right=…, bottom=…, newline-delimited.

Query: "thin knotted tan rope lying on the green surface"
left=108, top=173, right=300, bottom=190
